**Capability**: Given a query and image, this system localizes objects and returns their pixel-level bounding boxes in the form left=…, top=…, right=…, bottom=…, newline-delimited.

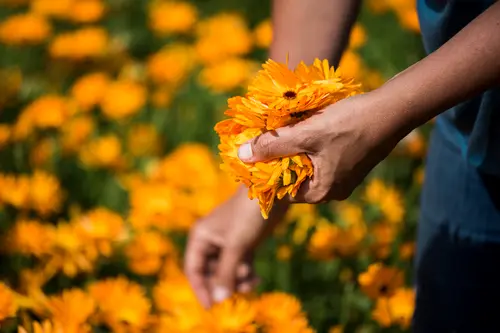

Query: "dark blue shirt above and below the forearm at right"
left=417, top=0, right=500, bottom=176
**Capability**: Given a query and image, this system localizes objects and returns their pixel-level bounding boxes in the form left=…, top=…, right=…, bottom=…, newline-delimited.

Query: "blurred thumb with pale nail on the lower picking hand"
left=212, top=246, right=244, bottom=303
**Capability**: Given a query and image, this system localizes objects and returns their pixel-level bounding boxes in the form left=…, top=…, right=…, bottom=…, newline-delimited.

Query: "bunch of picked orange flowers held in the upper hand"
left=215, top=59, right=361, bottom=219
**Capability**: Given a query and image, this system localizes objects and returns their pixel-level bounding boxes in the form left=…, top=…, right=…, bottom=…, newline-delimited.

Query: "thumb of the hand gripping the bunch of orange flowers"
left=238, top=126, right=302, bottom=163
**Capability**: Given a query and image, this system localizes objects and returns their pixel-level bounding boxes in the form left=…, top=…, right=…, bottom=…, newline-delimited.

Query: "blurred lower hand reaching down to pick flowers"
left=184, top=187, right=287, bottom=307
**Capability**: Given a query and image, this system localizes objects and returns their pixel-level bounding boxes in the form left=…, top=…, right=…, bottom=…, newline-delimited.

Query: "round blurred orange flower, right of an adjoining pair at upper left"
left=101, top=80, right=147, bottom=120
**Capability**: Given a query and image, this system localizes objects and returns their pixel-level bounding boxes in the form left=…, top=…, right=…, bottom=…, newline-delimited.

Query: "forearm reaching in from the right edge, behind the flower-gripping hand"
left=378, top=2, right=500, bottom=135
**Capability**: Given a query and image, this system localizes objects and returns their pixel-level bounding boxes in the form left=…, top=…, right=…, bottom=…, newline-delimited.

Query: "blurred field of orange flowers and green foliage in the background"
left=0, top=0, right=431, bottom=333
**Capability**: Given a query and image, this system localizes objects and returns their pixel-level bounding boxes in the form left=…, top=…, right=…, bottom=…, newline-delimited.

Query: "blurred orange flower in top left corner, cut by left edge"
left=0, top=13, right=52, bottom=45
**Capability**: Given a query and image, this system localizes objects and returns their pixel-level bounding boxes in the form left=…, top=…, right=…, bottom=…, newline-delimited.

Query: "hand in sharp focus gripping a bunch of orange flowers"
left=238, top=91, right=407, bottom=203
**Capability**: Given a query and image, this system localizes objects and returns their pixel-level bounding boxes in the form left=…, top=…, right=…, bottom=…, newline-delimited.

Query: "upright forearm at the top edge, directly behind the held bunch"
left=270, top=0, right=361, bottom=68
